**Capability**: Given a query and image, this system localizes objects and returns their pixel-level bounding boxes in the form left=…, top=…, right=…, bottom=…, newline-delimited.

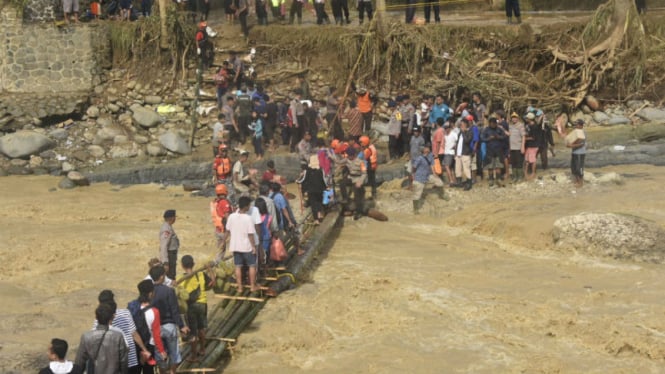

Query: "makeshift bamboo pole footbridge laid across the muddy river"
left=177, top=210, right=342, bottom=373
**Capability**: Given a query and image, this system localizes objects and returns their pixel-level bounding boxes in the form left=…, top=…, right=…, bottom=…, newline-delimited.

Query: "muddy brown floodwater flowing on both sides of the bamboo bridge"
left=0, top=166, right=665, bottom=373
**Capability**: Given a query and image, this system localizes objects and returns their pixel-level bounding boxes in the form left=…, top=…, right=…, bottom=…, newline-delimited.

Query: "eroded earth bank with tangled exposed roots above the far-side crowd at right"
left=254, top=0, right=665, bottom=109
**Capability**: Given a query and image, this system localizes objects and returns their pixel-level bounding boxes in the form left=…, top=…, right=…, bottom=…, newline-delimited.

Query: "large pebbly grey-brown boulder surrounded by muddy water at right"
left=552, top=213, right=665, bottom=263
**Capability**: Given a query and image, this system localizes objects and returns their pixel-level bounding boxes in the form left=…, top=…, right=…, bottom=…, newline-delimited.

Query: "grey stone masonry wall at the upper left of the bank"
left=0, top=7, right=110, bottom=93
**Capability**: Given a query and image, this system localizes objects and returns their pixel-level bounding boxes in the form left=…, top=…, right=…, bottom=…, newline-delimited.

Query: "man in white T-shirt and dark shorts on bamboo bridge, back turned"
left=224, top=196, right=259, bottom=293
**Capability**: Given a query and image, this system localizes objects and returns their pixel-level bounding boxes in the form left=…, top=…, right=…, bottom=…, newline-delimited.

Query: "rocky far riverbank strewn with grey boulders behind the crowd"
left=0, top=64, right=665, bottom=184
